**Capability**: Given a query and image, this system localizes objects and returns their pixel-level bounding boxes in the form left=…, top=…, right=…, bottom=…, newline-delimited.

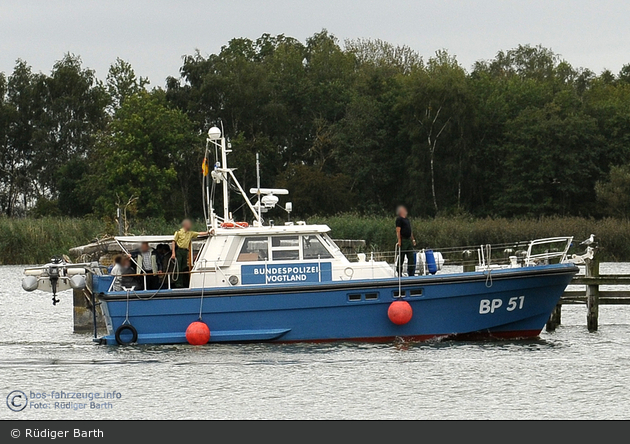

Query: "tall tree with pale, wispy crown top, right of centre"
left=332, top=40, right=423, bottom=213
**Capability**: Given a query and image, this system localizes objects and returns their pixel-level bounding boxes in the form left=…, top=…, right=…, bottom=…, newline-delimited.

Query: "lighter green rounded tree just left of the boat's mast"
left=83, top=90, right=203, bottom=218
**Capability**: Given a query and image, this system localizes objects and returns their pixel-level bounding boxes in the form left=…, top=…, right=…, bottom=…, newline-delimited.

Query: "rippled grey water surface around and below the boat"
left=0, top=264, right=630, bottom=419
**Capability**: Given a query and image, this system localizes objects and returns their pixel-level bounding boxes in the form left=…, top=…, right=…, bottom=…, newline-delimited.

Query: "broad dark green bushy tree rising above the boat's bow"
left=495, top=102, right=602, bottom=216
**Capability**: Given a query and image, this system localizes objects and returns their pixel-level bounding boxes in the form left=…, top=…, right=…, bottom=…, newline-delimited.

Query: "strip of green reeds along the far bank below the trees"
left=0, top=214, right=630, bottom=265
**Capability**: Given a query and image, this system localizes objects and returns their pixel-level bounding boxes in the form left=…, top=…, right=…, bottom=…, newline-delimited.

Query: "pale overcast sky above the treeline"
left=0, top=0, right=630, bottom=86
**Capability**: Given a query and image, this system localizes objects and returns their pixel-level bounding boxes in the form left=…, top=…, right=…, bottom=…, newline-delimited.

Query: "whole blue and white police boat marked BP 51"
left=23, top=127, right=593, bottom=345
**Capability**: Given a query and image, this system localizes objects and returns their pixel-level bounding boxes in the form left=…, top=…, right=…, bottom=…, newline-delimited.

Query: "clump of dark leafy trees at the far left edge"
left=0, top=54, right=109, bottom=215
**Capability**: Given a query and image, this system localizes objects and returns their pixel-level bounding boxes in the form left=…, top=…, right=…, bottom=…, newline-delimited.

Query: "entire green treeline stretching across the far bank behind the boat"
left=0, top=36, right=630, bottom=219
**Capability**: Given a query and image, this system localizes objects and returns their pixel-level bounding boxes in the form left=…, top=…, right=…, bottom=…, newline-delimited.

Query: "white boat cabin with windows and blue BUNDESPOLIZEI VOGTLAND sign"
left=190, top=224, right=394, bottom=288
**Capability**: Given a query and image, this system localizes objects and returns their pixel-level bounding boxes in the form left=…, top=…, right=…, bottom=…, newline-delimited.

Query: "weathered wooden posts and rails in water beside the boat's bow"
left=546, top=256, right=630, bottom=332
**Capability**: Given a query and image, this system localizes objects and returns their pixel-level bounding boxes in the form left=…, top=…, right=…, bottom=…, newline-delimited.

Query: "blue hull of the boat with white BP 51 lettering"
left=95, top=264, right=578, bottom=344
